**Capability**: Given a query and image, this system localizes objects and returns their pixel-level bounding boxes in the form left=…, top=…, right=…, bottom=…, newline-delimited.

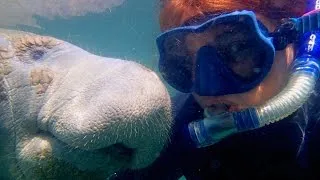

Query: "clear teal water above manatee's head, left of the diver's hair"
left=17, top=0, right=159, bottom=69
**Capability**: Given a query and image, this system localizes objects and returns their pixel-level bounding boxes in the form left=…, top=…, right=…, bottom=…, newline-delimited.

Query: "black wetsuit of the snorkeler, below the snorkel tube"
left=115, top=83, right=320, bottom=180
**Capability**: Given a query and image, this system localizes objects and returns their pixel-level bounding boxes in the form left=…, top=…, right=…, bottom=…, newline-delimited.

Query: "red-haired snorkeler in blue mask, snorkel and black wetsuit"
left=114, top=0, right=320, bottom=179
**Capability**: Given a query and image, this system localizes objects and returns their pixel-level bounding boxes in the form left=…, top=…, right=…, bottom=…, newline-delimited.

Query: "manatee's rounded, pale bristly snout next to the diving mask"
left=39, top=57, right=171, bottom=168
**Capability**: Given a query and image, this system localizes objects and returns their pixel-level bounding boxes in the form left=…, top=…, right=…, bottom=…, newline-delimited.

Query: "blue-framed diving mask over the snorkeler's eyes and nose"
left=157, top=10, right=292, bottom=96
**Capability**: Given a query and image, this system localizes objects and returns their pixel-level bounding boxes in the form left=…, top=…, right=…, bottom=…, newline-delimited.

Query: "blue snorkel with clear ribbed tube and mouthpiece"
left=188, top=1, right=320, bottom=148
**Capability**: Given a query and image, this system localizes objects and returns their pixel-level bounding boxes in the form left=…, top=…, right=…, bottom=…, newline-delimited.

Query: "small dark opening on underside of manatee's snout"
left=98, top=143, right=135, bottom=162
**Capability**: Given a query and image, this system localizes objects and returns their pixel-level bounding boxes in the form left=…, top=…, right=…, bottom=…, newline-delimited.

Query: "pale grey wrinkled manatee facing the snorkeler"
left=0, top=29, right=172, bottom=179
